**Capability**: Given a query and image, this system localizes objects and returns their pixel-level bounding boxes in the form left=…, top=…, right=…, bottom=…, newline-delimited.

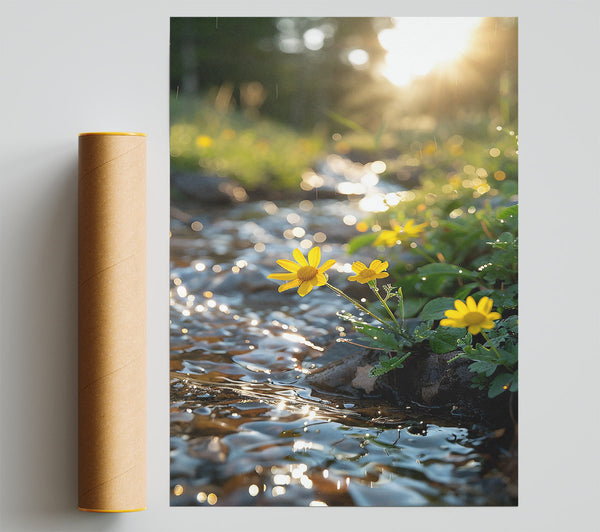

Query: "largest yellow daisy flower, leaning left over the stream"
left=267, top=246, right=335, bottom=297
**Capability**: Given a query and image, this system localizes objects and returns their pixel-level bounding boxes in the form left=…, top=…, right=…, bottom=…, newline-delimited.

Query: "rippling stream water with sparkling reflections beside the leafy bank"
left=171, top=161, right=515, bottom=506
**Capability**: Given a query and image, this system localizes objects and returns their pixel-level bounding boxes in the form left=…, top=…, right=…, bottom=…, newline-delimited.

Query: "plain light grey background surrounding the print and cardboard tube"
left=0, top=0, right=600, bottom=532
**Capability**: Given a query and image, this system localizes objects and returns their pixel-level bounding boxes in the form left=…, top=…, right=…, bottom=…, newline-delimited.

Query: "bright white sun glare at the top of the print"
left=378, top=17, right=481, bottom=87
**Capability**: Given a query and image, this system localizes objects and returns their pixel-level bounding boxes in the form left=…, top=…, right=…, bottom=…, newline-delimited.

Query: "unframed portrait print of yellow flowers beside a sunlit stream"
left=169, top=17, right=518, bottom=507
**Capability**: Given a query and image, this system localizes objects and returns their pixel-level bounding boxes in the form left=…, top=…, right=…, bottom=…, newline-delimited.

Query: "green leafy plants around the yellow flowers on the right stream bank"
left=340, top=196, right=518, bottom=397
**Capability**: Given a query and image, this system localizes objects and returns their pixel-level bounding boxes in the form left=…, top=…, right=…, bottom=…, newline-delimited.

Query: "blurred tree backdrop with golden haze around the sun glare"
left=171, top=17, right=517, bottom=132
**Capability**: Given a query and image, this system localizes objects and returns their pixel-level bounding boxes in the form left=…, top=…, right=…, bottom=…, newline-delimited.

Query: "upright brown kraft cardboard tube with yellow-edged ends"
left=79, top=133, right=146, bottom=512
